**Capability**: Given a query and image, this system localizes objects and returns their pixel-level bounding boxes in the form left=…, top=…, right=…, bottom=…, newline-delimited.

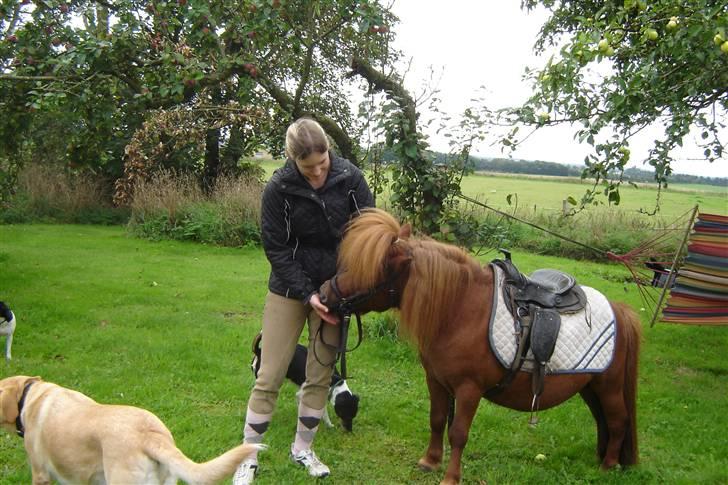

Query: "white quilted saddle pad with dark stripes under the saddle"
left=489, top=265, right=617, bottom=374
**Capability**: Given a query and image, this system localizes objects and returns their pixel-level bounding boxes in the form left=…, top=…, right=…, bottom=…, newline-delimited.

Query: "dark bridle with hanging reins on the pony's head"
left=313, top=266, right=401, bottom=379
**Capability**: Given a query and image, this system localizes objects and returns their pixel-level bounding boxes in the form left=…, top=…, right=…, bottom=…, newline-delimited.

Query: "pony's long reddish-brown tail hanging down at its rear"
left=612, top=303, right=642, bottom=467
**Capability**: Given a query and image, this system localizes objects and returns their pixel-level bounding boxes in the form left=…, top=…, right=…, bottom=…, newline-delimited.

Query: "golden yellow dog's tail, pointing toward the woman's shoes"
left=144, top=435, right=265, bottom=485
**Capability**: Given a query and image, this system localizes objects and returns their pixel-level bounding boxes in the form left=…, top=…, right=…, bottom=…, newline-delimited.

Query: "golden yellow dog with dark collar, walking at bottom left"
left=0, top=376, right=260, bottom=485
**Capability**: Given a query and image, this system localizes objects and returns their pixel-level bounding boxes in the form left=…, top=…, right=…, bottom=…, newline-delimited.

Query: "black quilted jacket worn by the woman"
left=261, top=152, right=374, bottom=302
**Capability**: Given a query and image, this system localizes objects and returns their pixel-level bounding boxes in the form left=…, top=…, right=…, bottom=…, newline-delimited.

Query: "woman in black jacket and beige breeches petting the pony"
left=233, top=118, right=374, bottom=485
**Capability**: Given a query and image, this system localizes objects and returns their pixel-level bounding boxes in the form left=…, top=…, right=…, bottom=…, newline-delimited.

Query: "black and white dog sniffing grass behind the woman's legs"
left=250, top=333, right=359, bottom=431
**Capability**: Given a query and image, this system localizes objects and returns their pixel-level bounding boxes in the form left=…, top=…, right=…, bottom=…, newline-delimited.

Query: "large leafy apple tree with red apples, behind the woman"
left=0, top=0, right=394, bottom=201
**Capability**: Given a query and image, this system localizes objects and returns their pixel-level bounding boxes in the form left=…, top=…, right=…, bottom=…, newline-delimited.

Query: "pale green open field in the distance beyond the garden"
left=261, top=161, right=728, bottom=220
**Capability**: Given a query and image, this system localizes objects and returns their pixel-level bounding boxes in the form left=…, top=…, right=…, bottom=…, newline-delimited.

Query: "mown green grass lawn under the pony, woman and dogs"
left=0, top=225, right=728, bottom=484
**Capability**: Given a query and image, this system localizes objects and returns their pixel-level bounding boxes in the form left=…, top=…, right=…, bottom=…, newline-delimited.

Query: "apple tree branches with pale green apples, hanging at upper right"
left=503, top=0, right=728, bottom=212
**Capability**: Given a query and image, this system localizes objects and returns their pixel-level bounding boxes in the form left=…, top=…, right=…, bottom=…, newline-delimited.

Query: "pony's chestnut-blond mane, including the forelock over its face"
left=338, top=209, right=485, bottom=350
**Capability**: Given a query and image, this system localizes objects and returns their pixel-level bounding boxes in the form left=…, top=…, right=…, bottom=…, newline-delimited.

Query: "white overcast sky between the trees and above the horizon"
left=393, top=0, right=728, bottom=177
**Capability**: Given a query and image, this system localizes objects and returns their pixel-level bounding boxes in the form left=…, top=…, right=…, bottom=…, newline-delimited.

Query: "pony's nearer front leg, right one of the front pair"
left=440, top=383, right=482, bottom=485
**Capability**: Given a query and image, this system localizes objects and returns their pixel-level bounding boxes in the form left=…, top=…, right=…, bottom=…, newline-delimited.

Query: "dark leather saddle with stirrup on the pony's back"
left=486, top=249, right=587, bottom=419
